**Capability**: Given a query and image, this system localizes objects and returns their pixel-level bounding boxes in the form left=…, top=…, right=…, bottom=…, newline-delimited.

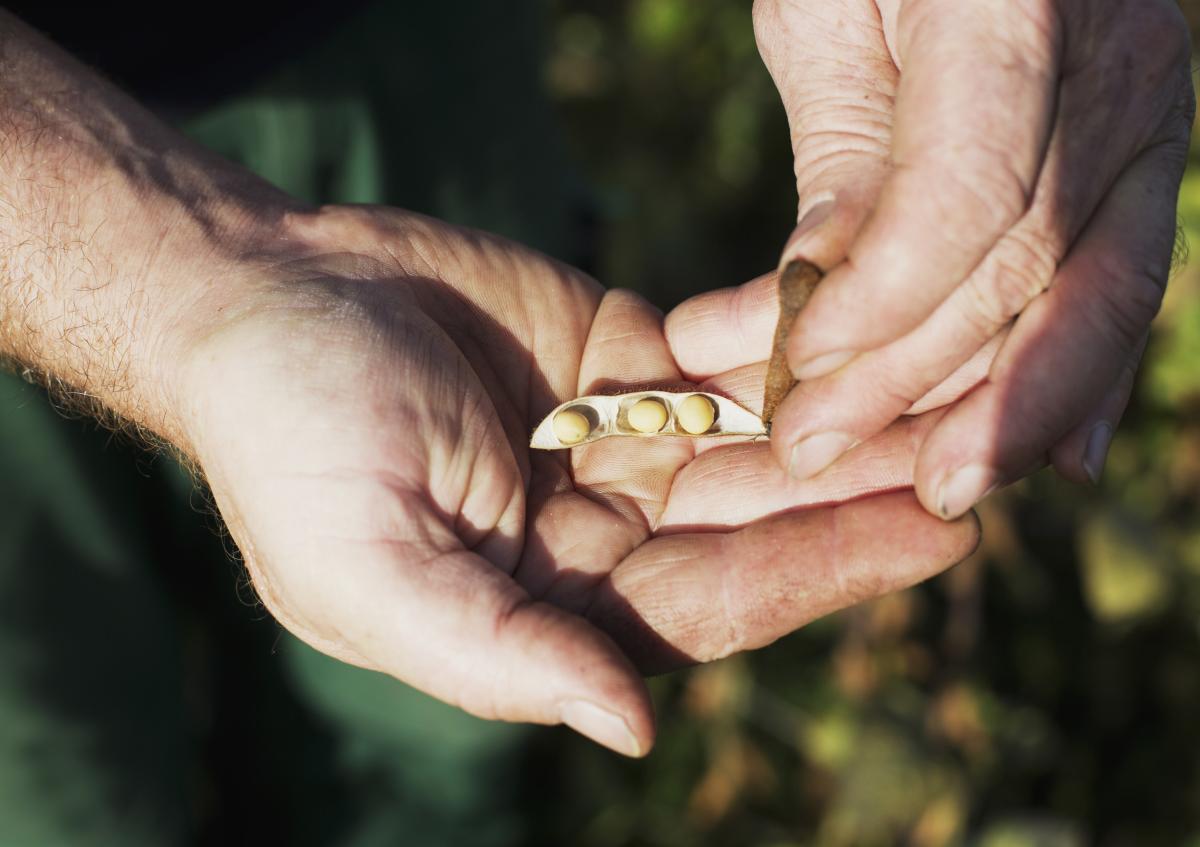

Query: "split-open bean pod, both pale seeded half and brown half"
left=529, top=259, right=822, bottom=450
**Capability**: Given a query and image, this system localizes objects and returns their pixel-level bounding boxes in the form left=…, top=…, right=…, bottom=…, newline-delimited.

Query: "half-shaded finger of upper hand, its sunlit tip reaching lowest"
left=916, top=143, right=1187, bottom=517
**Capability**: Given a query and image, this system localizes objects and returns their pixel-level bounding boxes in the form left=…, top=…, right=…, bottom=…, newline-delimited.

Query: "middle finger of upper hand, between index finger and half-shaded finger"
left=775, top=50, right=1158, bottom=467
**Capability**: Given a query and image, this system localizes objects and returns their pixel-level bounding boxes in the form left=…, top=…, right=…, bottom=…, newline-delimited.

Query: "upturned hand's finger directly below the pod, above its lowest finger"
left=655, top=410, right=944, bottom=534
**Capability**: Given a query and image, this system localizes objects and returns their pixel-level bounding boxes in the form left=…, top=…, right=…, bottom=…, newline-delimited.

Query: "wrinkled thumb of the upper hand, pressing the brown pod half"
left=754, top=0, right=899, bottom=270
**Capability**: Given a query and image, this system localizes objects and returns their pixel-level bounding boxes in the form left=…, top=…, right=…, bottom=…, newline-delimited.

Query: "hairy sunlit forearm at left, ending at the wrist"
left=0, top=12, right=292, bottom=450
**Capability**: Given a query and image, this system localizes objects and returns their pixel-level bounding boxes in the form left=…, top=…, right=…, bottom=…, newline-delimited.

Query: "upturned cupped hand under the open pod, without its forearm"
left=176, top=208, right=977, bottom=755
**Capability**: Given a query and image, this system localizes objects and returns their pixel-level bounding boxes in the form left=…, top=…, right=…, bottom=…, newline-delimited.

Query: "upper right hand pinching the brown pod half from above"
left=755, top=0, right=1194, bottom=517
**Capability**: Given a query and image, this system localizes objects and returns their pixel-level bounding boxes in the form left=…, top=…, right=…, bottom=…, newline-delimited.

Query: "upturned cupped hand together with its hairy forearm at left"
left=0, top=14, right=978, bottom=755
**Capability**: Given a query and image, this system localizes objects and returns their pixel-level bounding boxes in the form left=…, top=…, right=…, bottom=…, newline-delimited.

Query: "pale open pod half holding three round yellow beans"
left=529, top=391, right=767, bottom=450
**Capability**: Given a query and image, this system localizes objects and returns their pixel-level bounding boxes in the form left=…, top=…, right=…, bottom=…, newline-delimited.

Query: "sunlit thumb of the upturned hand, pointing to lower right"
left=272, top=519, right=654, bottom=756
